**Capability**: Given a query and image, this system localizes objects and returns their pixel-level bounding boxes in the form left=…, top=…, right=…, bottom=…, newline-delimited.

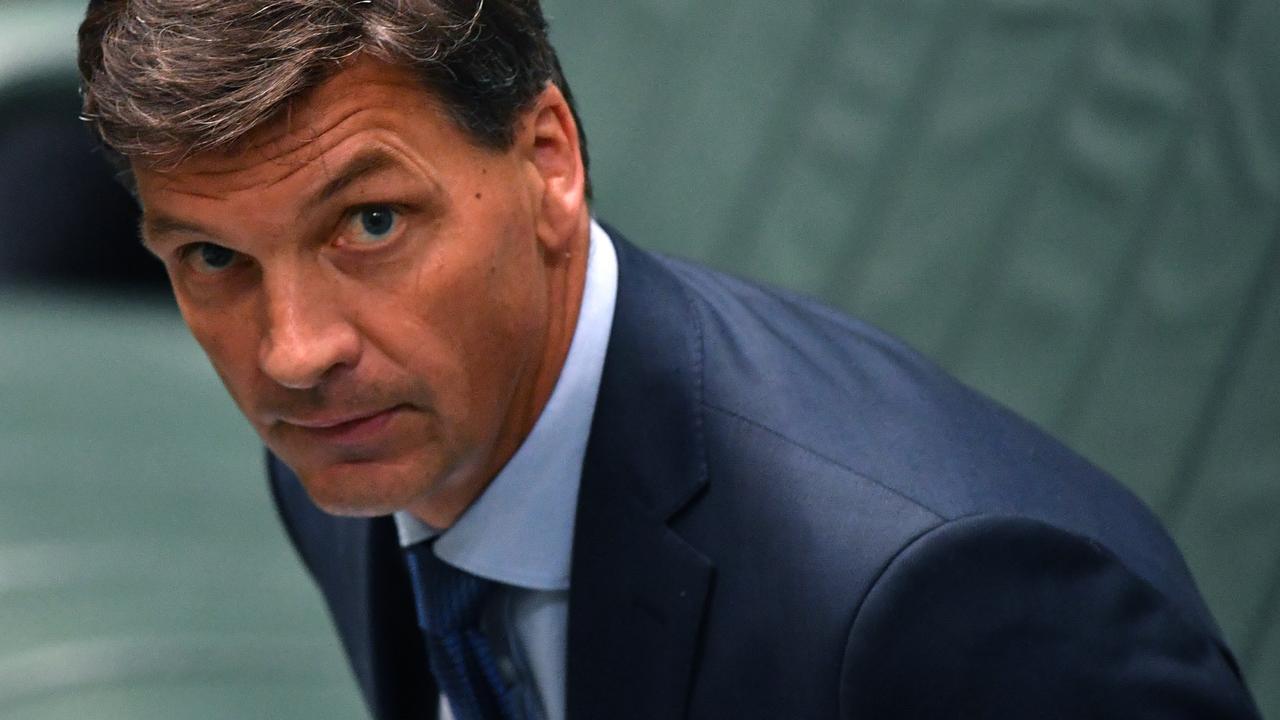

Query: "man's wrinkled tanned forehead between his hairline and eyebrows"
left=133, top=58, right=456, bottom=197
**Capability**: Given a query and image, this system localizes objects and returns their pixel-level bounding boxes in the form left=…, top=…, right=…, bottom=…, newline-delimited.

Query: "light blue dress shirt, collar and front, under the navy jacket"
left=396, top=220, right=618, bottom=720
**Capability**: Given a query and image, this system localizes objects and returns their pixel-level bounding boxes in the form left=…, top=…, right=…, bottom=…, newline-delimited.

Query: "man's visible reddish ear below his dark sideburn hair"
left=521, top=83, right=589, bottom=255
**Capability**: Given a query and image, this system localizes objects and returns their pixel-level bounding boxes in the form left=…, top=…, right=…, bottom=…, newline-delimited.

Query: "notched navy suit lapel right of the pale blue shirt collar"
left=567, top=231, right=713, bottom=720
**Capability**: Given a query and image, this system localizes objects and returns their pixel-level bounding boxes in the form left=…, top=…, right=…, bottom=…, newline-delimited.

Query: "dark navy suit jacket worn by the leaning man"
left=270, top=232, right=1257, bottom=720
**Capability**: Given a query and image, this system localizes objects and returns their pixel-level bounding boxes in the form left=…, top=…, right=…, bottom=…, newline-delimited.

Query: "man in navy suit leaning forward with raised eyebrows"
left=81, top=0, right=1256, bottom=720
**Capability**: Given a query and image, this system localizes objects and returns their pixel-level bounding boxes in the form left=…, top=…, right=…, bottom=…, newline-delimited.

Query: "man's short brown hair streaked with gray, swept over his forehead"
left=79, top=0, right=586, bottom=189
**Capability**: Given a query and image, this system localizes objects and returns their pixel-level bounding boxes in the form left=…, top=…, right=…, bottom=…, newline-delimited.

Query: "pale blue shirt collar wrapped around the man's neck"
left=396, top=219, right=618, bottom=591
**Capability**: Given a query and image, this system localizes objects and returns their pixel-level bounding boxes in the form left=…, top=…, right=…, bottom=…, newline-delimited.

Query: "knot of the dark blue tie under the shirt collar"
left=404, top=541, right=493, bottom=635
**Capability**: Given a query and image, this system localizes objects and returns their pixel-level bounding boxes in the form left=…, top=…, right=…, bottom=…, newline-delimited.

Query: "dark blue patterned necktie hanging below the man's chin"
left=404, top=541, right=521, bottom=720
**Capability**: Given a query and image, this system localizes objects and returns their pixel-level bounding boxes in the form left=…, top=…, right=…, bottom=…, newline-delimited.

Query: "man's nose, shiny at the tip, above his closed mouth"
left=259, top=266, right=360, bottom=389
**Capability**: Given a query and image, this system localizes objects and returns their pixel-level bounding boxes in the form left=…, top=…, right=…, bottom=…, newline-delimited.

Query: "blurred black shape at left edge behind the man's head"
left=0, top=76, right=168, bottom=293
